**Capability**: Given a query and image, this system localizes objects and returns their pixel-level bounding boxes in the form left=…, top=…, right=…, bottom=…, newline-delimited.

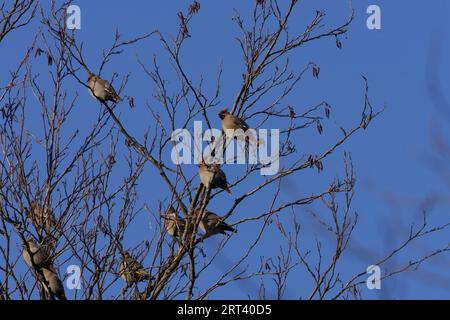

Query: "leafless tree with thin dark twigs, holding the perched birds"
left=0, top=0, right=449, bottom=300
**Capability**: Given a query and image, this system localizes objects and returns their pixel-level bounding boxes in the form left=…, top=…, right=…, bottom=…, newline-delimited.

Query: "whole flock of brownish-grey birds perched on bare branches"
left=22, top=73, right=256, bottom=300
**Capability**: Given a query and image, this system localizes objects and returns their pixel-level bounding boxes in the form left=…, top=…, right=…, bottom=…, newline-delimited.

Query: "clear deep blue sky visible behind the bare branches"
left=0, top=0, right=450, bottom=299
